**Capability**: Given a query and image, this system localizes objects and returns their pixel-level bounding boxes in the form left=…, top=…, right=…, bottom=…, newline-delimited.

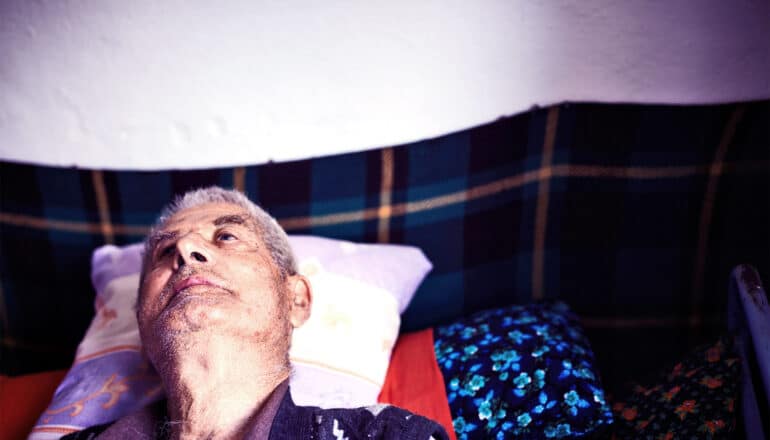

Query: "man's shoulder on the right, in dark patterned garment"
left=270, top=393, right=448, bottom=440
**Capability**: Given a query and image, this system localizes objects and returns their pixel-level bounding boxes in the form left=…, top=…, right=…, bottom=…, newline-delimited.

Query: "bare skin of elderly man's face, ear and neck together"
left=132, top=203, right=311, bottom=438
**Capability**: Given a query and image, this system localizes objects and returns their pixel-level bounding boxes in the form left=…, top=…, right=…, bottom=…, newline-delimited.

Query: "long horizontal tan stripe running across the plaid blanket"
left=0, top=161, right=770, bottom=237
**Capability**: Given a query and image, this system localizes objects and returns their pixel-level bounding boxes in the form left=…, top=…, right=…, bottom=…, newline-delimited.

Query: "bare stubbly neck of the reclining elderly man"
left=159, top=338, right=289, bottom=439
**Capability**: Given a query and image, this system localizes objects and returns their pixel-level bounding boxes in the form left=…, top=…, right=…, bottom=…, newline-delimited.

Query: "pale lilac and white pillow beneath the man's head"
left=32, top=236, right=431, bottom=438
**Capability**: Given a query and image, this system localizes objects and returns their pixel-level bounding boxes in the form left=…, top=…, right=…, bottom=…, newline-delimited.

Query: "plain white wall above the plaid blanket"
left=0, top=0, right=770, bottom=169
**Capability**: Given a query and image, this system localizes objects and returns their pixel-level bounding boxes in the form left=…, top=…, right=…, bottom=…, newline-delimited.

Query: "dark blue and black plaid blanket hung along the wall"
left=0, top=101, right=770, bottom=392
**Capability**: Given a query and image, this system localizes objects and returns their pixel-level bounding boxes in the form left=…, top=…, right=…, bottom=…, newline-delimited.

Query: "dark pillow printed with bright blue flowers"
left=434, top=302, right=612, bottom=439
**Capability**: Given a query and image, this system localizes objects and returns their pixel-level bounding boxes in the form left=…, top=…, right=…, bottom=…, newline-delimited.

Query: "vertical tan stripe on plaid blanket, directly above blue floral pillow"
left=532, top=106, right=559, bottom=301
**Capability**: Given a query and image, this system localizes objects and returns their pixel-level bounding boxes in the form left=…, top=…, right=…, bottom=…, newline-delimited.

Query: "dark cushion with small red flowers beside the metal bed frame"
left=612, top=338, right=740, bottom=440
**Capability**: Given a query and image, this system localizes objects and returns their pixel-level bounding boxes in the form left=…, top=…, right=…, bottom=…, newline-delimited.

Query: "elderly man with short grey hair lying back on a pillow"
left=63, top=187, right=446, bottom=440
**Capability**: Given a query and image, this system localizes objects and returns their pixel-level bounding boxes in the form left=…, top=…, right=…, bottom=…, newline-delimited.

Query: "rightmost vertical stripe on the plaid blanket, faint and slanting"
left=691, top=105, right=745, bottom=324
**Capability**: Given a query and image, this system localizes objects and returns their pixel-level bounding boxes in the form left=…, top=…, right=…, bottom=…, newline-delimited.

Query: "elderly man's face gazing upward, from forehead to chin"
left=137, top=203, right=293, bottom=359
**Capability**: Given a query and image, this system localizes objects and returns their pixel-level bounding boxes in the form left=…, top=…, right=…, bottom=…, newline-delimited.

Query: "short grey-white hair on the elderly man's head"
left=140, top=186, right=297, bottom=279
